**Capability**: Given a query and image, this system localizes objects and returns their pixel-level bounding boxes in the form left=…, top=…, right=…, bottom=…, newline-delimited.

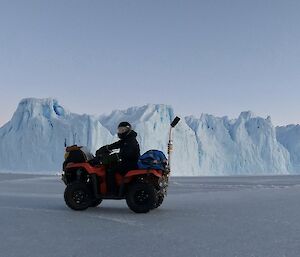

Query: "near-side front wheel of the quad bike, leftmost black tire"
left=64, top=182, right=91, bottom=211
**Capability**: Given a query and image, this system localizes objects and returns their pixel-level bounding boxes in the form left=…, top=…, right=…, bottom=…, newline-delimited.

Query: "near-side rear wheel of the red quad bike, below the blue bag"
left=126, top=182, right=157, bottom=213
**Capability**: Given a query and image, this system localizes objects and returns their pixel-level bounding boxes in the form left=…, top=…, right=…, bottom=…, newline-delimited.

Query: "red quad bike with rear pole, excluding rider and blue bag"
left=62, top=117, right=180, bottom=213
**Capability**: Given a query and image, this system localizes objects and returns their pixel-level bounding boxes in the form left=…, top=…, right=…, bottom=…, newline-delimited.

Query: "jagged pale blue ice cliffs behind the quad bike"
left=0, top=98, right=300, bottom=176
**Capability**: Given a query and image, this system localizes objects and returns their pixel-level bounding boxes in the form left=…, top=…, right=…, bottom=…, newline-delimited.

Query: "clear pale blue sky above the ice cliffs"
left=0, top=0, right=300, bottom=126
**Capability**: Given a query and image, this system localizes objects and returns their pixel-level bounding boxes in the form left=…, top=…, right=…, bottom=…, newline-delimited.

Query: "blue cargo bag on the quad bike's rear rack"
left=138, top=150, right=167, bottom=170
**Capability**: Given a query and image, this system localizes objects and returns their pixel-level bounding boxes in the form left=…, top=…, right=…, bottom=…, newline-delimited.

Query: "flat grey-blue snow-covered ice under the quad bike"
left=0, top=174, right=300, bottom=257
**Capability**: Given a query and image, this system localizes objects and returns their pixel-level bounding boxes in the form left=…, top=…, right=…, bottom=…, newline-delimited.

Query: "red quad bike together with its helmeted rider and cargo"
left=62, top=117, right=180, bottom=213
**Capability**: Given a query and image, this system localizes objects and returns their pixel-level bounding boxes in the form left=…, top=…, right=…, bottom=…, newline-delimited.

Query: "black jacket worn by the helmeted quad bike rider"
left=107, top=130, right=140, bottom=171
